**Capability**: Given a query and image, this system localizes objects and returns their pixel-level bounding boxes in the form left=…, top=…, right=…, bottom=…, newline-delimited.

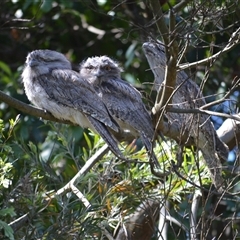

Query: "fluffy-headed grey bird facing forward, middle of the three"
left=80, top=56, right=162, bottom=176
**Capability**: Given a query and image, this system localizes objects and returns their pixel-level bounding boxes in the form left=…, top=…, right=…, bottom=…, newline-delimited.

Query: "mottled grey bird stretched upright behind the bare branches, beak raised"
left=143, top=42, right=228, bottom=189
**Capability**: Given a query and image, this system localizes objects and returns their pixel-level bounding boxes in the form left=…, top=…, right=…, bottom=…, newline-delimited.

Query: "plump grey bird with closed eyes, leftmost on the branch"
left=22, top=50, right=124, bottom=159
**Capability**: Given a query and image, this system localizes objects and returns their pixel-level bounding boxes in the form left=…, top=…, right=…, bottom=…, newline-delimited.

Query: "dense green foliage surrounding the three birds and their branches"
left=0, top=0, right=240, bottom=239
